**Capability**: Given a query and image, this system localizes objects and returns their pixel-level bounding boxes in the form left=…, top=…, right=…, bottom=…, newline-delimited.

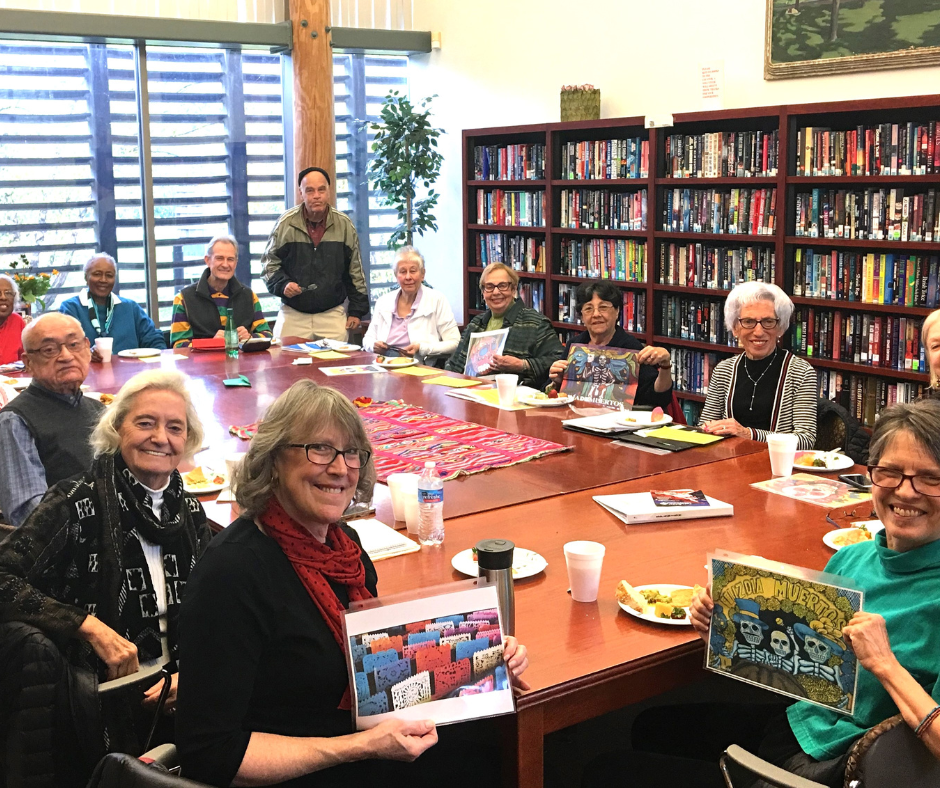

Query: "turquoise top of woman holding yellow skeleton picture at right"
left=787, top=531, right=940, bottom=760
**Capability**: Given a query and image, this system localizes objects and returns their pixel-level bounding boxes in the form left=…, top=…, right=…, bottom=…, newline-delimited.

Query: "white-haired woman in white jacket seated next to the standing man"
left=362, top=246, right=460, bottom=361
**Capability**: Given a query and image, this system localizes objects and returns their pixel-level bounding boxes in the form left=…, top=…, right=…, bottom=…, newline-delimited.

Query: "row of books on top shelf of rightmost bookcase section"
left=796, top=120, right=940, bottom=176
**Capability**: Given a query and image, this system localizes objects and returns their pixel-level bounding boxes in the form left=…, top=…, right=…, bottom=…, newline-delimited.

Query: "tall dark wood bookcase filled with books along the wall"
left=463, top=96, right=940, bottom=424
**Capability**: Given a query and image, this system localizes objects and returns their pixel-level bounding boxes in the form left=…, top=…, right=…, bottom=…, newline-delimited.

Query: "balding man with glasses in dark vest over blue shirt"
left=0, top=312, right=104, bottom=526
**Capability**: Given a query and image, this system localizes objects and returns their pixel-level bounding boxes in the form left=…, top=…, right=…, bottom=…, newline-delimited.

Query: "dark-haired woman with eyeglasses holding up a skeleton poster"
left=548, top=282, right=672, bottom=409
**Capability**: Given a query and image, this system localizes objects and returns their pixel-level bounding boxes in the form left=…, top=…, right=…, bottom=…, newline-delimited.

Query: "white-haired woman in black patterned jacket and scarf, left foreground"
left=0, top=370, right=210, bottom=785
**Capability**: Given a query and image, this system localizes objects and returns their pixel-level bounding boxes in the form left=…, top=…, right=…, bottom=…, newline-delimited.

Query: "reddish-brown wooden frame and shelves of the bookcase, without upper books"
left=462, top=96, right=940, bottom=430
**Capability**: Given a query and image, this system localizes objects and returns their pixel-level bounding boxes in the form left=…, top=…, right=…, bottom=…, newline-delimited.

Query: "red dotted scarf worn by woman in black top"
left=259, top=496, right=372, bottom=709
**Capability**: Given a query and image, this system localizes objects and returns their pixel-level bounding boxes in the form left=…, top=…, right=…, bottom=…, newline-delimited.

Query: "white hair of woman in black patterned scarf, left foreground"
left=91, top=369, right=204, bottom=460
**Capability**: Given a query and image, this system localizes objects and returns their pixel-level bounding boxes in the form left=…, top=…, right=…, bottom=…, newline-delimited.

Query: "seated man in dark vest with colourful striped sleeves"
left=170, top=235, right=271, bottom=347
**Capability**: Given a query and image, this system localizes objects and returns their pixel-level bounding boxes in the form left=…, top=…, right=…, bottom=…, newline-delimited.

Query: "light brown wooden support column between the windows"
left=290, top=0, right=336, bottom=203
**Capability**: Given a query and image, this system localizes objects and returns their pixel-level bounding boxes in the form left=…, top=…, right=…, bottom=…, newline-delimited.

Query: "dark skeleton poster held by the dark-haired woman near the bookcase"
left=561, top=345, right=640, bottom=410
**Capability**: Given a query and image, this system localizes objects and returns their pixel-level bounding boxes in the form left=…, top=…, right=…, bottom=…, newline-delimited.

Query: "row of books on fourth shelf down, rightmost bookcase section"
left=790, top=307, right=927, bottom=372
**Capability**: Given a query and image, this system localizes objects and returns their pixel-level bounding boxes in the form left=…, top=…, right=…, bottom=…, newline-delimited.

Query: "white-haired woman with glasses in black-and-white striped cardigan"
left=699, top=282, right=818, bottom=450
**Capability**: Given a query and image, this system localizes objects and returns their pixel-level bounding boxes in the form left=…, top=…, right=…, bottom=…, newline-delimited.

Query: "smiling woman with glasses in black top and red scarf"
left=177, top=380, right=528, bottom=786
